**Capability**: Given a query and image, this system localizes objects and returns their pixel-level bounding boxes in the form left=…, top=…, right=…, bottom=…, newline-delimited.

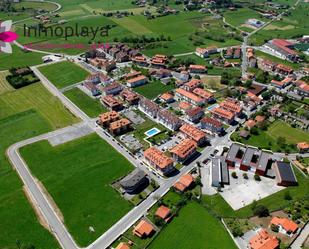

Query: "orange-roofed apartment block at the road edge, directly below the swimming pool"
left=144, top=147, right=174, bottom=175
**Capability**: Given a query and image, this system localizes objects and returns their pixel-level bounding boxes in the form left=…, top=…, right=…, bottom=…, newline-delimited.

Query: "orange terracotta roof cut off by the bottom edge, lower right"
left=249, top=229, right=279, bottom=249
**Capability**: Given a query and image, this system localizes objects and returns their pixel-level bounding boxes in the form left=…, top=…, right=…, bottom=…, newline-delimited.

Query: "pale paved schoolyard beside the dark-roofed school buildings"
left=220, top=169, right=284, bottom=210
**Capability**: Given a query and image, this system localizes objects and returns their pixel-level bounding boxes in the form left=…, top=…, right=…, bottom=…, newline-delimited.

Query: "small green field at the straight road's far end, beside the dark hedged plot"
left=39, top=61, right=89, bottom=89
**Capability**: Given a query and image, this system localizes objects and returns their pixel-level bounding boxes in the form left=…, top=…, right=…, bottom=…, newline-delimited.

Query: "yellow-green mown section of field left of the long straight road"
left=0, top=83, right=78, bottom=129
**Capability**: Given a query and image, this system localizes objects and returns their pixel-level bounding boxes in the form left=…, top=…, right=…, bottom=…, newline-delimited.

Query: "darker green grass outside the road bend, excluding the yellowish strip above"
left=0, top=111, right=60, bottom=249
